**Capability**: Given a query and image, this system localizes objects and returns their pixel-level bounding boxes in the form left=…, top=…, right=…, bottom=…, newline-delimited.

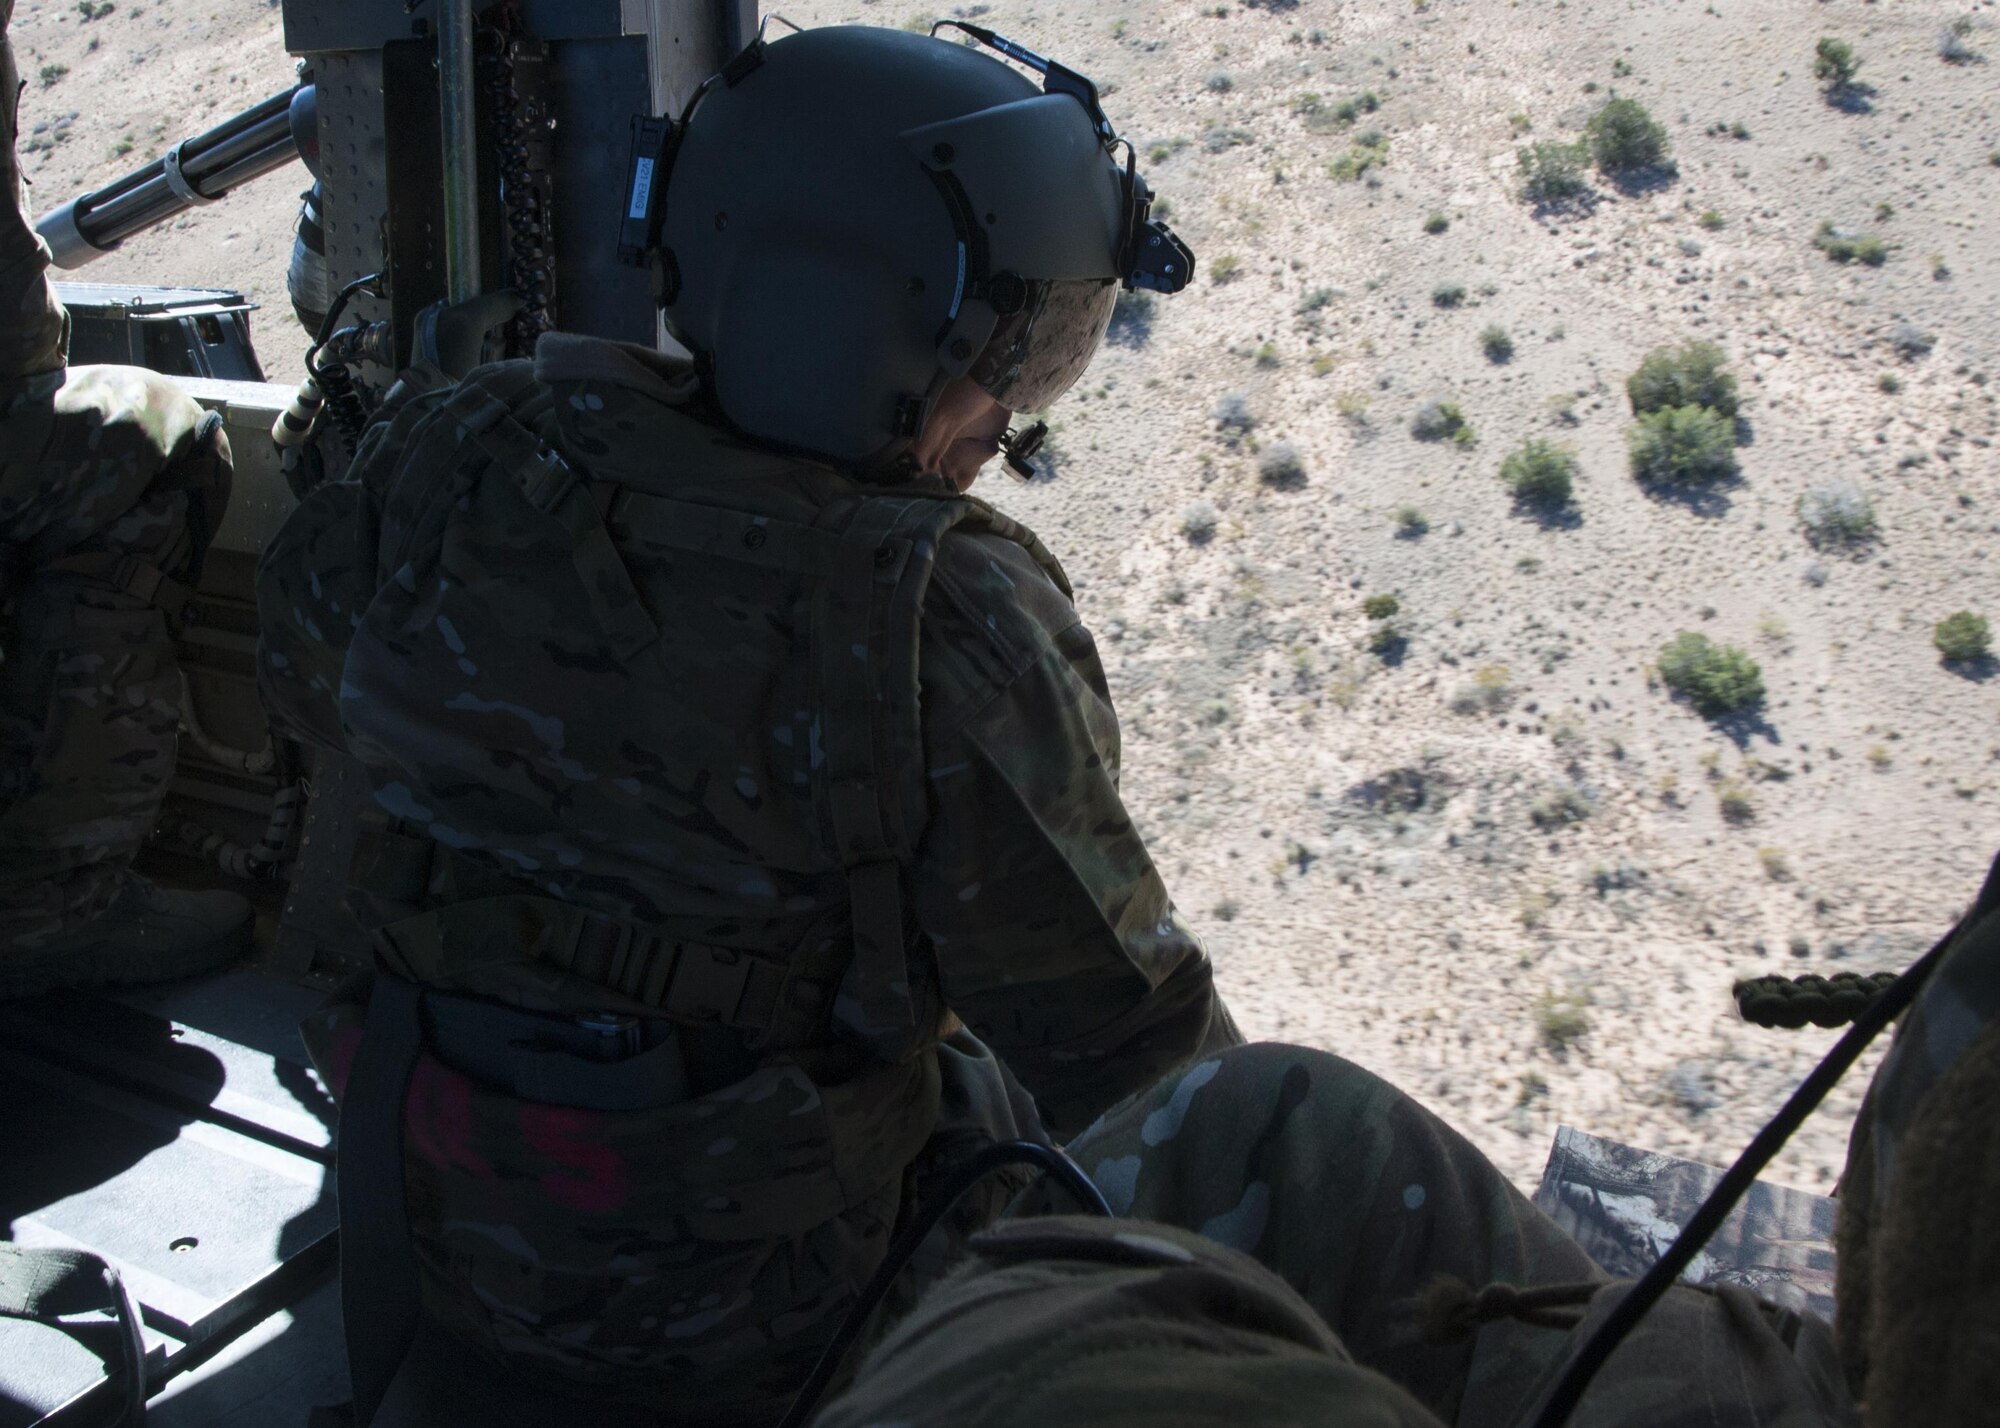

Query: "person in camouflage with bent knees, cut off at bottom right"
left=812, top=864, right=2000, bottom=1428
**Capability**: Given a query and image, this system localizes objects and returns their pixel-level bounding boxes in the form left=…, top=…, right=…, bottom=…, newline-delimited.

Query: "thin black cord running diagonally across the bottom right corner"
left=1534, top=916, right=1970, bottom=1428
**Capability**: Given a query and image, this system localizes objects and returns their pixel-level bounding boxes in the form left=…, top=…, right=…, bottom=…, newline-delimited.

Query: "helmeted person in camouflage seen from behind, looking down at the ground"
left=258, top=19, right=1240, bottom=1424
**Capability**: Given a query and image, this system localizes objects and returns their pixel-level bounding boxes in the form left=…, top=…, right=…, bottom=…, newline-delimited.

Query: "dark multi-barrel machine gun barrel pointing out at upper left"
left=36, top=88, right=298, bottom=268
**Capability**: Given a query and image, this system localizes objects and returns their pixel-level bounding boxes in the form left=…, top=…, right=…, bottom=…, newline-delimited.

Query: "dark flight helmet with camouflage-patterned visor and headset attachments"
left=620, top=22, right=1194, bottom=470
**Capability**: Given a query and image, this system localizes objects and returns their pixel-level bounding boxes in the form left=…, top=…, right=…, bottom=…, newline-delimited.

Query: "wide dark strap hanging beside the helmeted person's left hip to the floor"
left=334, top=972, right=424, bottom=1428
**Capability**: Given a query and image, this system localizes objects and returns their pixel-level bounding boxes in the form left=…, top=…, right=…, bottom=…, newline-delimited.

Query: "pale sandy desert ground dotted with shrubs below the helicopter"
left=16, top=0, right=2000, bottom=1190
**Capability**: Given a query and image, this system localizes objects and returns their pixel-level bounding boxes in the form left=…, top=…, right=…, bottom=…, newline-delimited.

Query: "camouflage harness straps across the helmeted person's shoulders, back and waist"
left=324, top=362, right=1068, bottom=1058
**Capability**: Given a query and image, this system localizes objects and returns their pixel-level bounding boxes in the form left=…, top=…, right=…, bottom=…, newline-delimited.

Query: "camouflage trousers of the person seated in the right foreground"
left=814, top=1044, right=1852, bottom=1428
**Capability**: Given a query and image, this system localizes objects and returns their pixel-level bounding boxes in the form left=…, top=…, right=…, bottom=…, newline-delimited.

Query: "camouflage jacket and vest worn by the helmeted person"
left=258, top=336, right=1234, bottom=1390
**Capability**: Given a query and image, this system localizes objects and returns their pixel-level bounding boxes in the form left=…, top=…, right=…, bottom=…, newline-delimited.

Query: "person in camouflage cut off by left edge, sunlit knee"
left=0, top=0, right=250, bottom=996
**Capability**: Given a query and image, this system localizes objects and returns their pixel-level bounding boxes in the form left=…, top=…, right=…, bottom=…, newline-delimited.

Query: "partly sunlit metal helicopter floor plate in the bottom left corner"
left=0, top=972, right=336, bottom=1424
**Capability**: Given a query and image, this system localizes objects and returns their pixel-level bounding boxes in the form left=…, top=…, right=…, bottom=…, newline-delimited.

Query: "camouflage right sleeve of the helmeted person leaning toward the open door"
left=912, top=536, right=1238, bottom=1136
